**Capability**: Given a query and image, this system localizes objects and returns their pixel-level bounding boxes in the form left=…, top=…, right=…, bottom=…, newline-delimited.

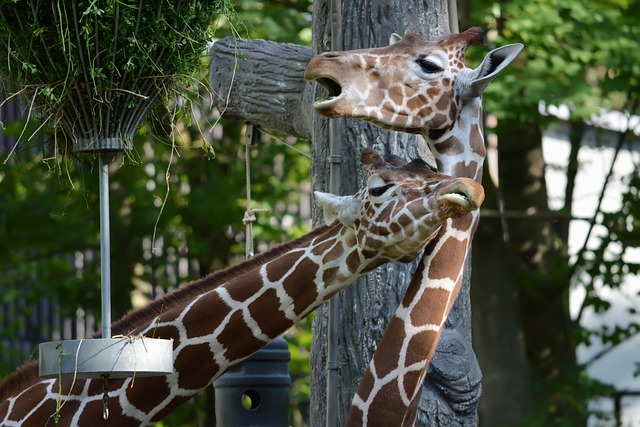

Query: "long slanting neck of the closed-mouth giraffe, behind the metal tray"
left=0, top=225, right=379, bottom=426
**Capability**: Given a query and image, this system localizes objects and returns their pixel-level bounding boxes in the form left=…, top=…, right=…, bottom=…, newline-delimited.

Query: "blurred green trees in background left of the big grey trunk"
left=0, top=1, right=311, bottom=426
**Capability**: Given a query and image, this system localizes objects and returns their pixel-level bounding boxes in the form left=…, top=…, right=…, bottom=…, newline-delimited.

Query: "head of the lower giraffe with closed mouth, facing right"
left=315, top=148, right=484, bottom=262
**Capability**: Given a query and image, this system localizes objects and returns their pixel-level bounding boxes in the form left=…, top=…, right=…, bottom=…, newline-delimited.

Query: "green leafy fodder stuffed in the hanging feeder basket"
left=0, top=0, right=233, bottom=91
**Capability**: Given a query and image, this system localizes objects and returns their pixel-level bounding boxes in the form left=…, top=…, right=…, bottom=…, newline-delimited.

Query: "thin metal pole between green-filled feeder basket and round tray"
left=98, top=153, right=111, bottom=338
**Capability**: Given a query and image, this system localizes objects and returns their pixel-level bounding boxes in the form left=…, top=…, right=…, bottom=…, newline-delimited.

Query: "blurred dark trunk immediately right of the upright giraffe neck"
left=471, top=164, right=532, bottom=426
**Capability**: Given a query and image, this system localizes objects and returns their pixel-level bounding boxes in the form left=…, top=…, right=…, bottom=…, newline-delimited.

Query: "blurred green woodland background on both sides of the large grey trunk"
left=0, top=0, right=640, bottom=426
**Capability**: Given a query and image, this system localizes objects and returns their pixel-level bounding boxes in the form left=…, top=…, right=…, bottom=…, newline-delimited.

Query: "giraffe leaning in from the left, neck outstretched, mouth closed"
left=0, top=149, right=484, bottom=427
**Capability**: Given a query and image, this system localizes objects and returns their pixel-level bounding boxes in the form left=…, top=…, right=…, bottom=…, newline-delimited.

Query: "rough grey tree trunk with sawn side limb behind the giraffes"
left=211, top=0, right=481, bottom=426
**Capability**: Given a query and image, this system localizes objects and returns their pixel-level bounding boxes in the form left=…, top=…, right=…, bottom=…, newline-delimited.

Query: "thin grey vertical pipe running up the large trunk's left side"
left=327, top=0, right=344, bottom=427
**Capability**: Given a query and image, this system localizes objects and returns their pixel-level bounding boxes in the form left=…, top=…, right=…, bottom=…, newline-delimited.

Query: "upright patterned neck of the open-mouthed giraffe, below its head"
left=346, top=98, right=486, bottom=426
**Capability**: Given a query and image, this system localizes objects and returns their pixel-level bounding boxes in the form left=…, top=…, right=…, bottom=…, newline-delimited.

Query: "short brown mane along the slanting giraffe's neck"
left=0, top=224, right=332, bottom=403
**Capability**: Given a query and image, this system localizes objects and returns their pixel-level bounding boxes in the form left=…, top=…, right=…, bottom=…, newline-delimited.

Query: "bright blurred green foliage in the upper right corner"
left=473, top=0, right=640, bottom=128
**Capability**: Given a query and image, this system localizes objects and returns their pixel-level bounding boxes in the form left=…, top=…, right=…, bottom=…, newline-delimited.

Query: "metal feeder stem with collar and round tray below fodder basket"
left=38, top=138, right=173, bottom=381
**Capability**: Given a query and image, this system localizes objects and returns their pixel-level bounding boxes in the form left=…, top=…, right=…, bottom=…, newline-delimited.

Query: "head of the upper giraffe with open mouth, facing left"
left=304, top=28, right=523, bottom=133
